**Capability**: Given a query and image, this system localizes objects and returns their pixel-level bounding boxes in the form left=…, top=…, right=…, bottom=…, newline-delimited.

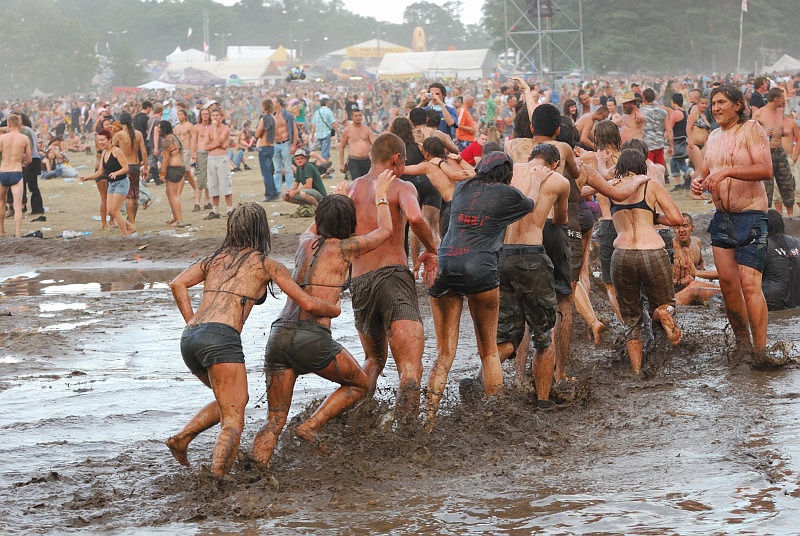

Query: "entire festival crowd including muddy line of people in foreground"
left=0, top=71, right=800, bottom=474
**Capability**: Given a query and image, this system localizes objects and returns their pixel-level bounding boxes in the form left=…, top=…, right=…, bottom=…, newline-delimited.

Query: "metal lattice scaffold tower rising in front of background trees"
left=503, top=0, right=584, bottom=79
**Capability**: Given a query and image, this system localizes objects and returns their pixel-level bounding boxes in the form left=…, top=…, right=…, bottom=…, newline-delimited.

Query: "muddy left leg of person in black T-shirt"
left=425, top=293, right=466, bottom=432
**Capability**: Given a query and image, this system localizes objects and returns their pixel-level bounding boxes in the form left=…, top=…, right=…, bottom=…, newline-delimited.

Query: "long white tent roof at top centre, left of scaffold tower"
left=378, top=48, right=494, bottom=79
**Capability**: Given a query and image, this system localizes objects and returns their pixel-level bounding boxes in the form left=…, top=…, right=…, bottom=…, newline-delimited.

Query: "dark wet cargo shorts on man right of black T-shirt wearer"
left=497, top=244, right=556, bottom=351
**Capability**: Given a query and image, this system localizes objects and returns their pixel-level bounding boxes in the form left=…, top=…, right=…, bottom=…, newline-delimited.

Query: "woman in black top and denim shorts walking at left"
left=81, top=130, right=136, bottom=235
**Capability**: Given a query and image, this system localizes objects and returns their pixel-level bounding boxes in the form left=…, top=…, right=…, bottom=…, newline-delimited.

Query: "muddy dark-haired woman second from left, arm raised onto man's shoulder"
left=252, top=171, right=394, bottom=465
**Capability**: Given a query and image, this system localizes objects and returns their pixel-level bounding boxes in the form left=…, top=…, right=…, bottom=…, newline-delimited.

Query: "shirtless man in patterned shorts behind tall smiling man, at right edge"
left=753, top=87, right=795, bottom=218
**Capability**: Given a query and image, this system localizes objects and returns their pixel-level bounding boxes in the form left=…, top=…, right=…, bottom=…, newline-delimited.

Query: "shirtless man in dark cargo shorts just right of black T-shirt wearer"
left=497, top=143, right=570, bottom=401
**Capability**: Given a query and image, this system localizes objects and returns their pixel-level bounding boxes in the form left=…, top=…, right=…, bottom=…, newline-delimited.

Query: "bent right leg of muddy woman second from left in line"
left=295, top=349, right=370, bottom=453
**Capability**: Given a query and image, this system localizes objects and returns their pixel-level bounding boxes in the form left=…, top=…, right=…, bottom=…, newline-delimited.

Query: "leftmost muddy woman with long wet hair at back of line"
left=166, top=203, right=340, bottom=475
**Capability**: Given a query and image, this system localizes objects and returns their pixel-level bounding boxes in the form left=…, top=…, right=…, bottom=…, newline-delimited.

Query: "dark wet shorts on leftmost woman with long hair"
left=181, top=322, right=244, bottom=375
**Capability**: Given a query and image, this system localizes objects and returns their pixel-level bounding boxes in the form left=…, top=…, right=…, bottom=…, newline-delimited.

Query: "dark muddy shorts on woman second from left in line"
left=264, top=318, right=342, bottom=374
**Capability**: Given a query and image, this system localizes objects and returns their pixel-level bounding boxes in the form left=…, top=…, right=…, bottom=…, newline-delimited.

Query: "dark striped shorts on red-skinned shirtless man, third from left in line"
left=350, top=264, right=422, bottom=337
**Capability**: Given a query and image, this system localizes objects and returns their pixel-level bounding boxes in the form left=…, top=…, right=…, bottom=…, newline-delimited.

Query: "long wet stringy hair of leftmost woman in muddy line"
left=200, top=203, right=272, bottom=278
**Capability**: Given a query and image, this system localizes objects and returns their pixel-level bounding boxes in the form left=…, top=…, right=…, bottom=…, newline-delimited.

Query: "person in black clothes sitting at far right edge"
left=761, top=209, right=800, bottom=311
